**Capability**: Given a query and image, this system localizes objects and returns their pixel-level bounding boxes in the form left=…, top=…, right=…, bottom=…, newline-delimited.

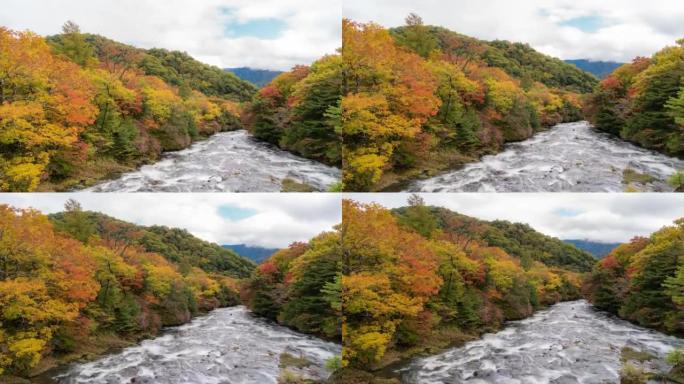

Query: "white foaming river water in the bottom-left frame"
left=54, top=306, right=341, bottom=384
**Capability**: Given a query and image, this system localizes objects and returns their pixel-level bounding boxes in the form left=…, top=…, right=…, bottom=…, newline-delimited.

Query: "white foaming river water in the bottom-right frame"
left=400, top=301, right=684, bottom=384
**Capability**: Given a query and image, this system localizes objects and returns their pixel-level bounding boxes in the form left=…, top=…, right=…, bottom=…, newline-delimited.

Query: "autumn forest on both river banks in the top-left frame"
left=0, top=22, right=341, bottom=192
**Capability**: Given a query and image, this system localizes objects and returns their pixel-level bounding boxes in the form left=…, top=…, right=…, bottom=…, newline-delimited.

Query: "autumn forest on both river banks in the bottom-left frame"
left=0, top=200, right=342, bottom=377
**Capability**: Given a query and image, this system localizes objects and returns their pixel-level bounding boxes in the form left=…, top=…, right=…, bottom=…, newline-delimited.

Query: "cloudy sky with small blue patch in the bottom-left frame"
left=0, top=193, right=342, bottom=248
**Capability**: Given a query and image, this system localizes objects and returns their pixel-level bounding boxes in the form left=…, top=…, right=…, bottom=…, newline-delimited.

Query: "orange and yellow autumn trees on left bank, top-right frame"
left=342, top=15, right=597, bottom=191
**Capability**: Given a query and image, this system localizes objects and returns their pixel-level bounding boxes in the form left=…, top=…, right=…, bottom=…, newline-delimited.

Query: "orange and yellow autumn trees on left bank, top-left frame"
left=0, top=23, right=256, bottom=191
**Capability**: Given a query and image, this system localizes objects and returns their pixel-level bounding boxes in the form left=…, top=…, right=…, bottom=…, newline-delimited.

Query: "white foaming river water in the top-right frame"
left=408, top=121, right=684, bottom=192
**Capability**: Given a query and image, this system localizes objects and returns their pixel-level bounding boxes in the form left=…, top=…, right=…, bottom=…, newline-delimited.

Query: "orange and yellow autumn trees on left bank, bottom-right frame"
left=340, top=195, right=592, bottom=376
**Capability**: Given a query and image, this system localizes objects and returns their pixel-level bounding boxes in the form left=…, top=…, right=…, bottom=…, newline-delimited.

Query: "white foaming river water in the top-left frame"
left=86, top=131, right=341, bottom=192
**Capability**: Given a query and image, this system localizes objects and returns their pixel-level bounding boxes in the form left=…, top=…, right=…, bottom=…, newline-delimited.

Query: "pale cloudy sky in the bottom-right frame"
left=347, top=193, right=684, bottom=242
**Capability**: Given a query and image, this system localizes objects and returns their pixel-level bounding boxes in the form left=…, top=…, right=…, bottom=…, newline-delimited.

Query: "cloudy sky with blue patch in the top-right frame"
left=343, top=0, right=684, bottom=62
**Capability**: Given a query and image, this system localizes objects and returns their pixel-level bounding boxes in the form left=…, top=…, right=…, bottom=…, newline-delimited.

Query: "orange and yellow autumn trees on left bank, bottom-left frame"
left=0, top=201, right=253, bottom=376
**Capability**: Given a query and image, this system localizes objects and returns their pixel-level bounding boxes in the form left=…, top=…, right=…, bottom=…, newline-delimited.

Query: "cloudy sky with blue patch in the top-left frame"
left=0, top=0, right=342, bottom=70
